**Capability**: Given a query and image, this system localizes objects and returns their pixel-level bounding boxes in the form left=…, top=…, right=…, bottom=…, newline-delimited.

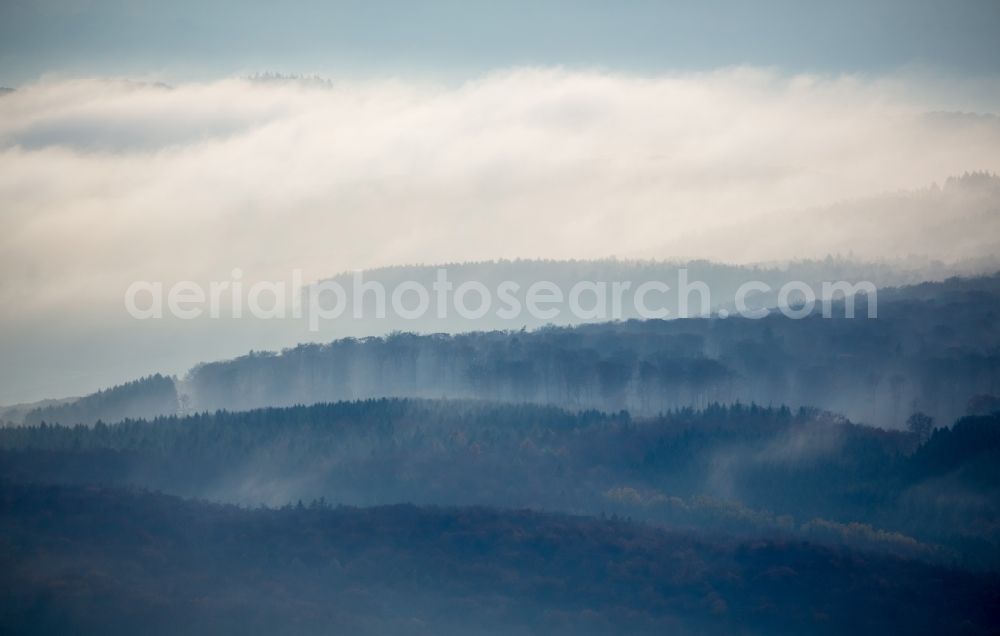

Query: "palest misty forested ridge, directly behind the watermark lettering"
left=310, top=256, right=976, bottom=333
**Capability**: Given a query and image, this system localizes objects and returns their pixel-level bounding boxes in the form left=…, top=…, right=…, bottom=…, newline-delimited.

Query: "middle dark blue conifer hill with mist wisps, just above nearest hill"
left=0, top=400, right=1000, bottom=568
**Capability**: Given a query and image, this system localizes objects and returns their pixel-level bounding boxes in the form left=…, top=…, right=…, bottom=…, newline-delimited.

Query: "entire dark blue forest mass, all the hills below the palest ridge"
left=0, top=279, right=1000, bottom=636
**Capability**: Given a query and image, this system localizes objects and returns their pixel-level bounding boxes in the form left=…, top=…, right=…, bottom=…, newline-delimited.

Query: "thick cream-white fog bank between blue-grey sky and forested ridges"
left=0, top=68, right=1000, bottom=401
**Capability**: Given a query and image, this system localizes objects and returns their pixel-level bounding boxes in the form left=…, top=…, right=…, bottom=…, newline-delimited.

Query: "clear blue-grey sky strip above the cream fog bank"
left=0, top=0, right=1000, bottom=86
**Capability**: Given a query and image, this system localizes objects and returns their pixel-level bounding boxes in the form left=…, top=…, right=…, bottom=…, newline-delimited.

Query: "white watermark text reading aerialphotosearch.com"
left=124, top=268, right=877, bottom=331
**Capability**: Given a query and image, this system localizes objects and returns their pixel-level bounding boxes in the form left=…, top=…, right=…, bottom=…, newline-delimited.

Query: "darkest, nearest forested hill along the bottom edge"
left=0, top=484, right=1000, bottom=636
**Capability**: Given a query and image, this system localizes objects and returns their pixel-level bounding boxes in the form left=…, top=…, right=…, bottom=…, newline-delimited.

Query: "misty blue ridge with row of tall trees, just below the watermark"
left=7, top=275, right=1000, bottom=428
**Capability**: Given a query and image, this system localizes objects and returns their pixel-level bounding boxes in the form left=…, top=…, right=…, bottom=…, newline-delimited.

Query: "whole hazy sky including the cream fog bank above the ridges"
left=0, top=0, right=1000, bottom=403
